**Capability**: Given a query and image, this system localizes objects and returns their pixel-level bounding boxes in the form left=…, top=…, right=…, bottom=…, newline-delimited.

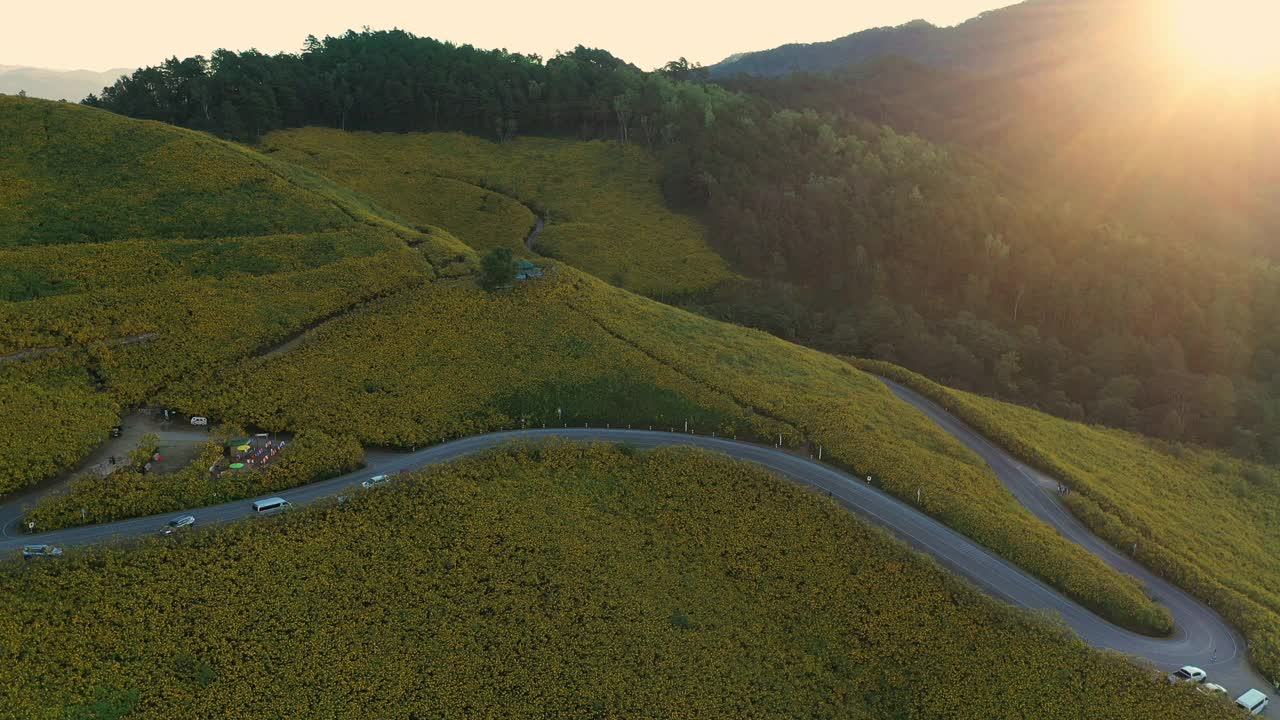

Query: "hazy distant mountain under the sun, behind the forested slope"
left=712, top=0, right=1280, bottom=256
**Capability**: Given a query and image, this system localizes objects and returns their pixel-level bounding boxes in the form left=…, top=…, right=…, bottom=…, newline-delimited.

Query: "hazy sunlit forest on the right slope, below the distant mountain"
left=670, top=110, right=1280, bottom=459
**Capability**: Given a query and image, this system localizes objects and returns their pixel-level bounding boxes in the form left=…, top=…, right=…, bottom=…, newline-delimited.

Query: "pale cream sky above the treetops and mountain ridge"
left=0, top=0, right=1014, bottom=70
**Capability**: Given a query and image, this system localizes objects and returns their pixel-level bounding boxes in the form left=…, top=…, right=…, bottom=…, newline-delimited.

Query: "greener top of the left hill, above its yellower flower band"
left=0, top=96, right=351, bottom=247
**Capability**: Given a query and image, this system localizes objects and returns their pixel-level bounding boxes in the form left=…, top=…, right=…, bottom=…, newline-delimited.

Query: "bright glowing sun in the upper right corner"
left=1169, top=0, right=1280, bottom=78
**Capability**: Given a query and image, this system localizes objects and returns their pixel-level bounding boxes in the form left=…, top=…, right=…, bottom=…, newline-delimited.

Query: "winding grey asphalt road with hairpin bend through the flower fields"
left=0, top=420, right=1270, bottom=697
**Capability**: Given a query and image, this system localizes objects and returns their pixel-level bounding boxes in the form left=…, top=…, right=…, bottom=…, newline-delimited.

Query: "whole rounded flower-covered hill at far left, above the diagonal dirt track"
left=0, top=97, right=474, bottom=493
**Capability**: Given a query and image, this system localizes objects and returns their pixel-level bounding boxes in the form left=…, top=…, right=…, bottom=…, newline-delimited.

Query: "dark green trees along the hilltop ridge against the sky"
left=84, top=29, right=723, bottom=146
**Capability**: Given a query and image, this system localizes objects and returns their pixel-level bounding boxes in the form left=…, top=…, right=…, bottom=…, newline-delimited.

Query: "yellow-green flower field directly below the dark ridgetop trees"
left=262, top=128, right=731, bottom=296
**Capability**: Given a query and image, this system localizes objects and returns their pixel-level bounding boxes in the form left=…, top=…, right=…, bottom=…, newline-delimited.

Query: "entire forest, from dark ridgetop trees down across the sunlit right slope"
left=86, top=31, right=1280, bottom=460
